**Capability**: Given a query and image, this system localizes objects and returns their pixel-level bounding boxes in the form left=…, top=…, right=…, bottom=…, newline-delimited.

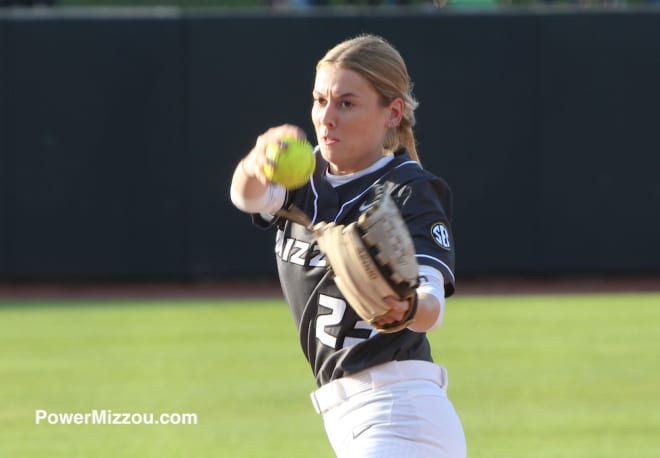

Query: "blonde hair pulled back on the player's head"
left=316, top=35, right=419, bottom=162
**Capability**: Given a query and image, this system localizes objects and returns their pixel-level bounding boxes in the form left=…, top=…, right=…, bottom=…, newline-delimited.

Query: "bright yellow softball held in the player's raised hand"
left=264, top=137, right=316, bottom=189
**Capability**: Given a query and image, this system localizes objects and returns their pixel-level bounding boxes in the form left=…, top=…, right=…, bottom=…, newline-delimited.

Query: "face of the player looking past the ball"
left=312, top=64, right=393, bottom=175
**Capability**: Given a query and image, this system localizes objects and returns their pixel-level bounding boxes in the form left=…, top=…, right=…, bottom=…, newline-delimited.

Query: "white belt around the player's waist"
left=310, top=360, right=447, bottom=414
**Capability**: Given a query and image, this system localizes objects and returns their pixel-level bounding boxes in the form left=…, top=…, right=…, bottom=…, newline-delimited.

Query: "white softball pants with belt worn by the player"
left=311, top=361, right=467, bottom=458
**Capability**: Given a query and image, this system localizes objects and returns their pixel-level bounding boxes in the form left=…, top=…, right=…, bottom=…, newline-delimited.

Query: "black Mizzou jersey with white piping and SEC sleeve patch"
left=253, top=150, right=454, bottom=386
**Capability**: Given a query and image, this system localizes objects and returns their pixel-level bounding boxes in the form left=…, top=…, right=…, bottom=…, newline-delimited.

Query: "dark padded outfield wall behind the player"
left=0, top=9, right=660, bottom=280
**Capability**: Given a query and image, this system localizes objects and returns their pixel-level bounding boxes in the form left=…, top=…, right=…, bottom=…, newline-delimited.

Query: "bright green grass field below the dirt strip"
left=0, top=294, right=660, bottom=458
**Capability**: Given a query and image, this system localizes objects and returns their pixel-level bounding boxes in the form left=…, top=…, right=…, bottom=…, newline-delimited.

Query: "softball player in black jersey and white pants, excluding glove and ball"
left=231, top=35, right=466, bottom=458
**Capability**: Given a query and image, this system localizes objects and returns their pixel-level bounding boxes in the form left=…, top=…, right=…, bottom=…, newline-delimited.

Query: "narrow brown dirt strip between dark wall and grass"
left=0, top=276, right=660, bottom=302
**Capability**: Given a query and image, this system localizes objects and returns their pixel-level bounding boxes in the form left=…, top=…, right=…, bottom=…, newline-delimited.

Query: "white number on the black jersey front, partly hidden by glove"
left=316, top=294, right=376, bottom=350
